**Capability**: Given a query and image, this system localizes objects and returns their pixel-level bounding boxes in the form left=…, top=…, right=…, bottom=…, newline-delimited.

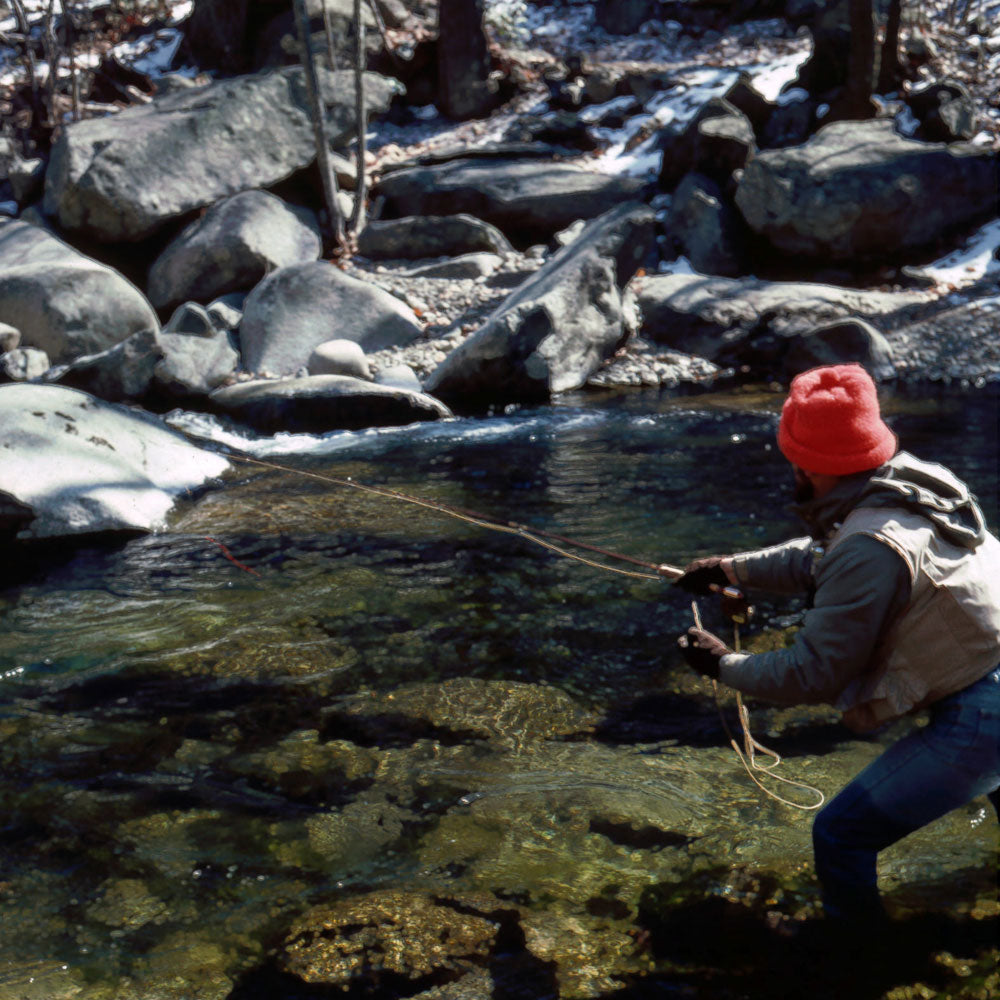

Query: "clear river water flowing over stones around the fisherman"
left=0, top=386, right=1000, bottom=1000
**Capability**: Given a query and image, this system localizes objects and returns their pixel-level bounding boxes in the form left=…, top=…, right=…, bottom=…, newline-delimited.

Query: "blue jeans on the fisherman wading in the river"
left=813, top=667, right=1000, bottom=923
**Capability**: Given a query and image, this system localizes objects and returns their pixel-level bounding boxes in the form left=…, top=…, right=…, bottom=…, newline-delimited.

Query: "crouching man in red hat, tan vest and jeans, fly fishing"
left=677, top=365, right=1000, bottom=930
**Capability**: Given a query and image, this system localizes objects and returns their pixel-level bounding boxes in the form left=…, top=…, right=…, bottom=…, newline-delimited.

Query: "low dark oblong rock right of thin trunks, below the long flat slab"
left=358, top=214, right=511, bottom=260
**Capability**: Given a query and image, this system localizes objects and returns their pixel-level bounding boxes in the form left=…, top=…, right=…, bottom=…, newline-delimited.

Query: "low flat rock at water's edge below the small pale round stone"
left=210, top=375, right=451, bottom=434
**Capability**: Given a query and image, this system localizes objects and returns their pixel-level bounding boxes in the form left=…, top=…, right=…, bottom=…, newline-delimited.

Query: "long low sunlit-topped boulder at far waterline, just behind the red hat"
left=636, top=274, right=926, bottom=367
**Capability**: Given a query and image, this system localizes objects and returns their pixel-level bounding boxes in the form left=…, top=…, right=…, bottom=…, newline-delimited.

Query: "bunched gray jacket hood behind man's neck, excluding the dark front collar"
left=857, top=451, right=986, bottom=549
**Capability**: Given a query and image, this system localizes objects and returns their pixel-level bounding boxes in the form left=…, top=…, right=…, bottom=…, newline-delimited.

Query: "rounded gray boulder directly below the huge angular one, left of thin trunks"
left=147, top=191, right=323, bottom=309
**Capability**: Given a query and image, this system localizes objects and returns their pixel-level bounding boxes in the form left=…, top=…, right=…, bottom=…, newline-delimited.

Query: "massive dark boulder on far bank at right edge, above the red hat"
left=736, top=120, right=1000, bottom=261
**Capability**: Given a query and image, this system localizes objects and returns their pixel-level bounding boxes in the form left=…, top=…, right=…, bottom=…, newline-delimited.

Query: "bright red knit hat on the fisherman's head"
left=778, top=364, right=897, bottom=476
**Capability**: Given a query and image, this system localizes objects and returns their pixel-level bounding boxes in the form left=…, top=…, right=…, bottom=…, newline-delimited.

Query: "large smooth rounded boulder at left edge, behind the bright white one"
left=0, top=222, right=159, bottom=363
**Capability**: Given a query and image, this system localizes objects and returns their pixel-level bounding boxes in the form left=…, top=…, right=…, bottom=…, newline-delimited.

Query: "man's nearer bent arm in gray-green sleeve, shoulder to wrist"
left=719, top=535, right=912, bottom=705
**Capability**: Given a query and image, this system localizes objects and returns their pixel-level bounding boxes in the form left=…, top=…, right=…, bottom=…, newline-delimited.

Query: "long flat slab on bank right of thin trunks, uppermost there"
left=375, top=158, right=645, bottom=246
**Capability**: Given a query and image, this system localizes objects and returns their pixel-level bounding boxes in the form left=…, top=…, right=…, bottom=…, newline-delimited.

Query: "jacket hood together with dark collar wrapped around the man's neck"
left=794, top=451, right=986, bottom=549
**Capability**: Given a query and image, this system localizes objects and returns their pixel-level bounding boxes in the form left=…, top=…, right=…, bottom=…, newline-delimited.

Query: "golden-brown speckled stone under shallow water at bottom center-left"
left=281, top=890, right=499, bottom=989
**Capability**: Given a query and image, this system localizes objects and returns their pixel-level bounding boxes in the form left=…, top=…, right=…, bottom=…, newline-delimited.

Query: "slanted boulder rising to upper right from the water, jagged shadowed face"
left=424, top=202, right=654, bottom=407
